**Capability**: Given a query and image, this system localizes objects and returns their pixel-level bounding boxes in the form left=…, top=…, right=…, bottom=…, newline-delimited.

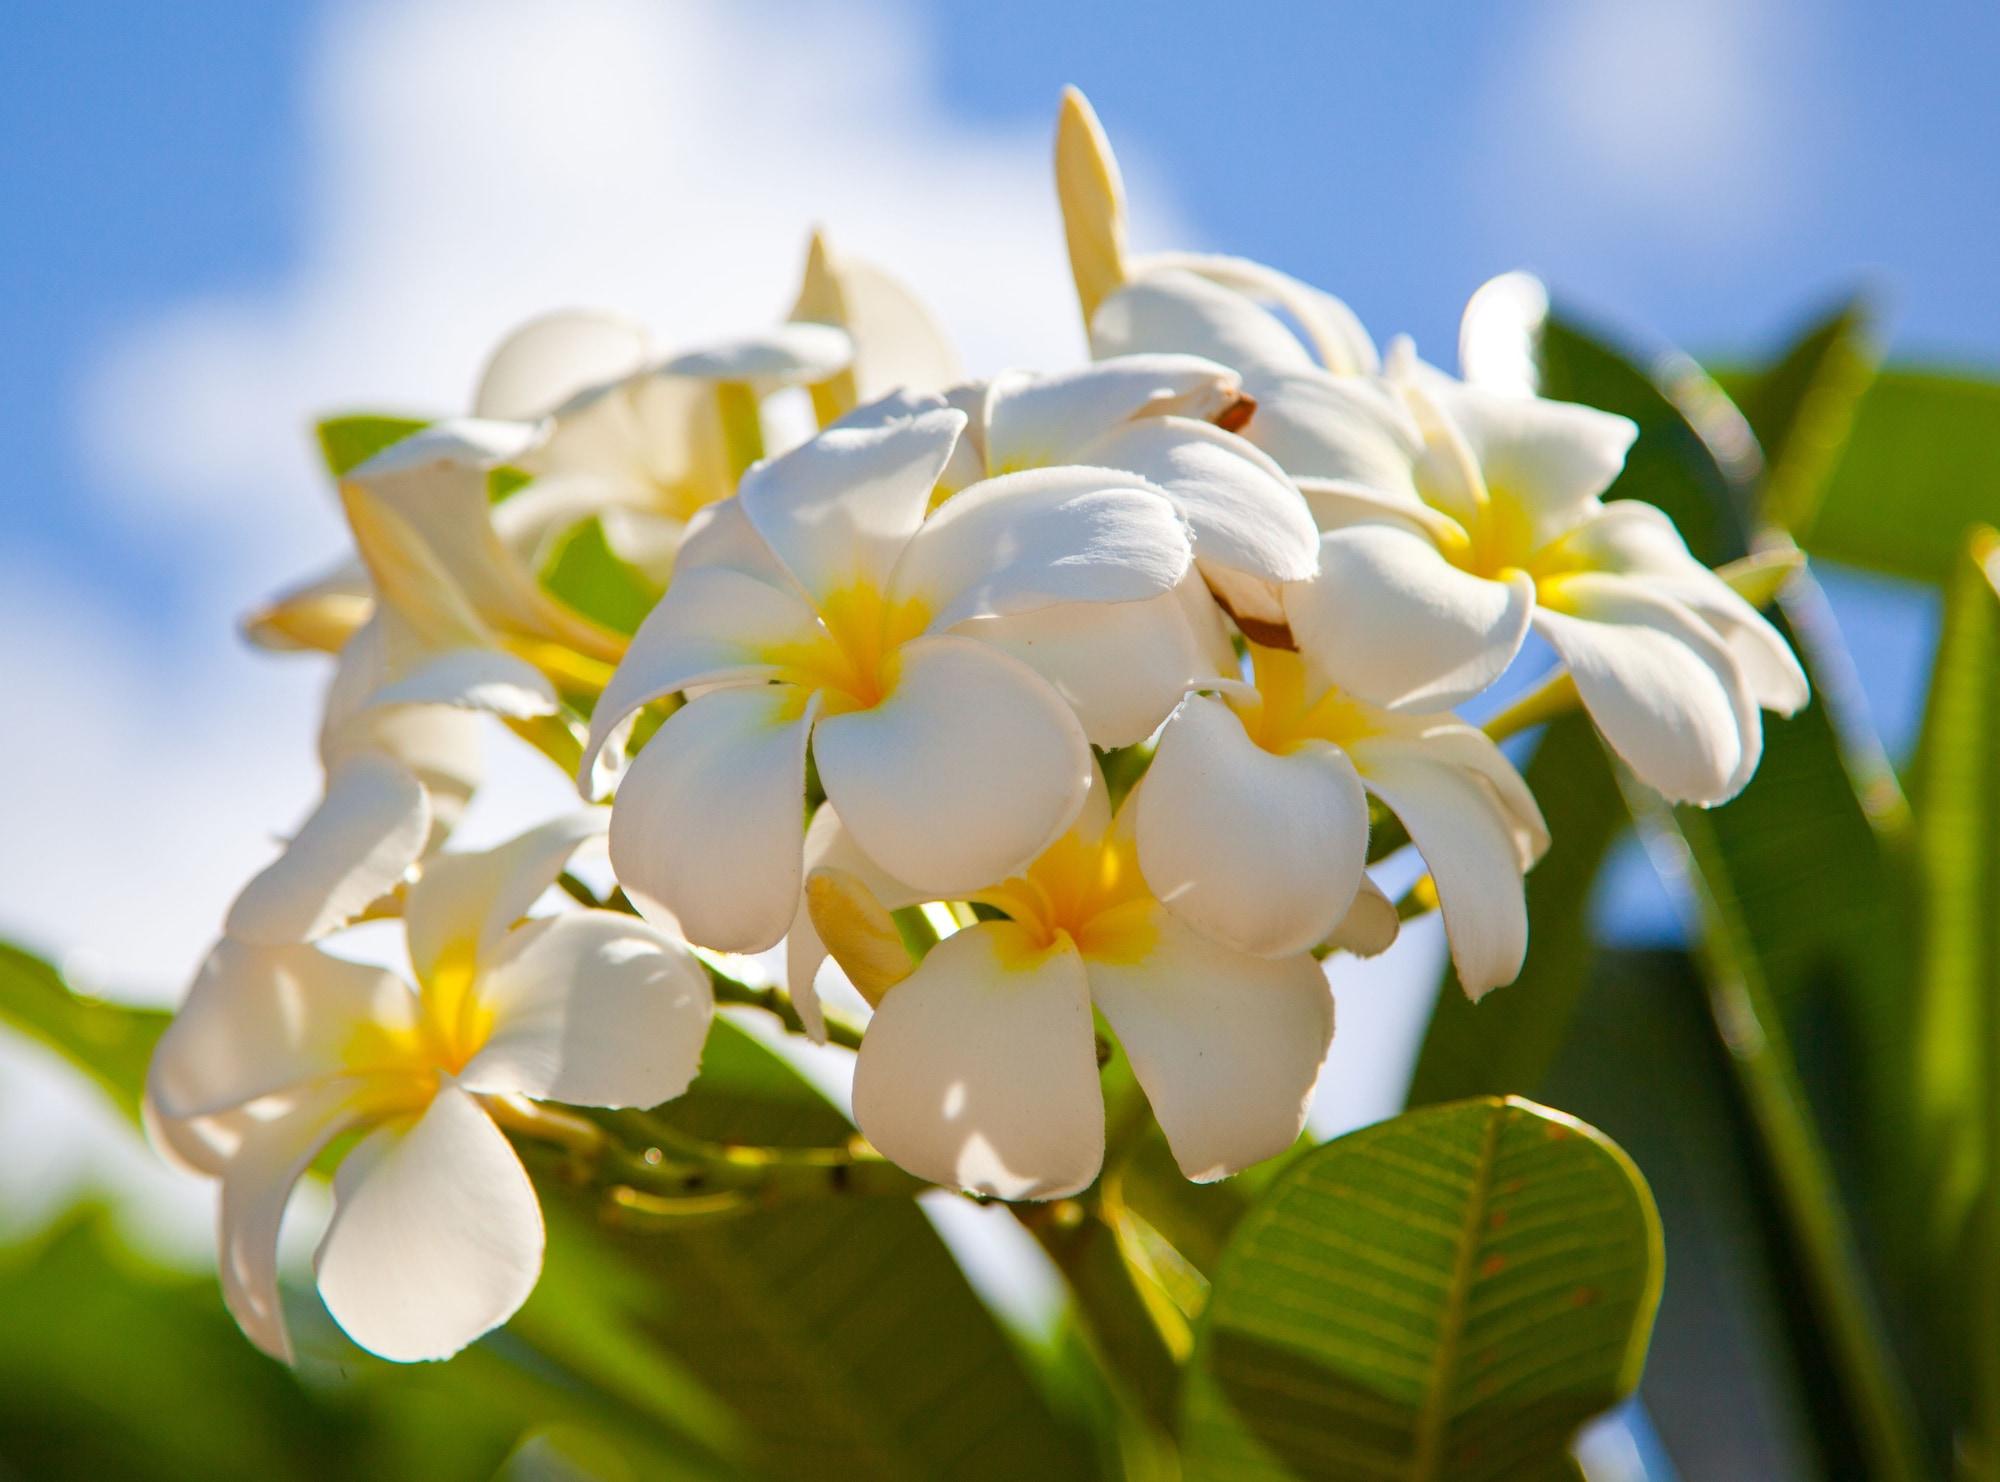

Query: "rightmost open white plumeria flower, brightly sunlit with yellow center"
left=1286, top=348, right=1808, bottom=804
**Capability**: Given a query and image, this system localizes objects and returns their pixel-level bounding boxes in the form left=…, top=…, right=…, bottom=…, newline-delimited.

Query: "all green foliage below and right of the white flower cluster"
left=0, top=300, right=2000, bottom=1478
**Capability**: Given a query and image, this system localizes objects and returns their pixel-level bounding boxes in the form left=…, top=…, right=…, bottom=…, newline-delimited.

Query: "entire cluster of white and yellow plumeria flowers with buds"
left=148, top=94, right=1806, bottom=1358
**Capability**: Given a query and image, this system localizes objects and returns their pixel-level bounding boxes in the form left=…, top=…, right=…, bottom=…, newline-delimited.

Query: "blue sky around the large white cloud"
left=11, top=0, right=2000, bottom=628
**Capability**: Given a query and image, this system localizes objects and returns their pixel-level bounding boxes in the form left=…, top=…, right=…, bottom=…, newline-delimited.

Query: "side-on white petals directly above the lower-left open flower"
left=224, top=622, right=480, bottom=946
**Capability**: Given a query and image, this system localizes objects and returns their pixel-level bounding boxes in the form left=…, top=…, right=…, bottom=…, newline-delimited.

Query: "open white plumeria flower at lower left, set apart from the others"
left=146, top=810, right=714, bottom=1360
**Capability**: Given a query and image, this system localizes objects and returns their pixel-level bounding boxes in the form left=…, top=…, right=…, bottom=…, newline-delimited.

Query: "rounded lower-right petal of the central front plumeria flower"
left=816, top=636, right=1092, bottom=896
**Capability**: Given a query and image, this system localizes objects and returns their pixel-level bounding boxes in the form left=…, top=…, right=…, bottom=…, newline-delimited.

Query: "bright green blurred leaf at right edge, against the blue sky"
left=1798, top=370, right=2000, bottom=582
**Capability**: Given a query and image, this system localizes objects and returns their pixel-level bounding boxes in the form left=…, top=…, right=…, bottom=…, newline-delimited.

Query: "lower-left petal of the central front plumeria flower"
left=612, top=684, right=818, bottom=952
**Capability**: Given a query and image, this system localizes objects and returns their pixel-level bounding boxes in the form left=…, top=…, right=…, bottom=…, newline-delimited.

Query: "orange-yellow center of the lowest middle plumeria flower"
left=972, top=816, right=1156, bottom=962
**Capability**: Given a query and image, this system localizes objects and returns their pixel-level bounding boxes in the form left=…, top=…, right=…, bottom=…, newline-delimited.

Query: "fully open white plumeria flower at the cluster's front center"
left=580, top=410, right=1190, bottom=952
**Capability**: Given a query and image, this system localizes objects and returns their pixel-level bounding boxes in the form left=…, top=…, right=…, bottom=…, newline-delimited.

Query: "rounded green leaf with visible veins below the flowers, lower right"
left=1182, top=1098, right=1662, bottom=1482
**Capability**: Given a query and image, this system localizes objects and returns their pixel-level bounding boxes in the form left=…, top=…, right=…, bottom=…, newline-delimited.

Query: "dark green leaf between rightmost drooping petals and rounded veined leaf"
left=1408, top=714, right=1628, bottom=1106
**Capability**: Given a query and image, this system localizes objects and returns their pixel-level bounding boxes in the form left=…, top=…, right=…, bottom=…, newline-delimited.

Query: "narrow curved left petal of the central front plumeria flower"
left=578, top=562, right=820, bottom=794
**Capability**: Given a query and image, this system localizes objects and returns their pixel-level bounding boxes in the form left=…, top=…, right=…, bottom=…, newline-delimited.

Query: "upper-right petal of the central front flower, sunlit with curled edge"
left=892, top=466, right=1192, bottom=632
